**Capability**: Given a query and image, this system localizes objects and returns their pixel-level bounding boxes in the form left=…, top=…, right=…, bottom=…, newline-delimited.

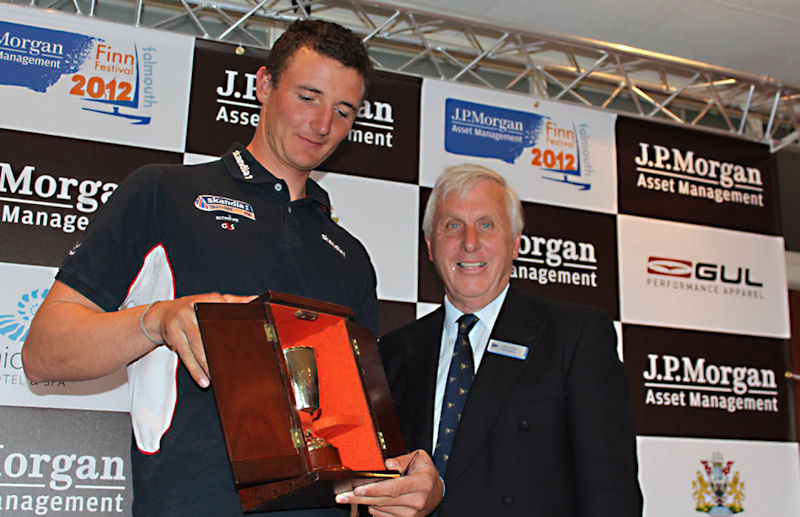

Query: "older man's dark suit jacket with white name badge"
left=380, top=286, right=642, bottom=517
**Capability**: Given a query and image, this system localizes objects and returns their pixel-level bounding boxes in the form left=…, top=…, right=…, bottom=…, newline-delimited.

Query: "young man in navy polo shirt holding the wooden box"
left=23, top=21, right=442, bottom=516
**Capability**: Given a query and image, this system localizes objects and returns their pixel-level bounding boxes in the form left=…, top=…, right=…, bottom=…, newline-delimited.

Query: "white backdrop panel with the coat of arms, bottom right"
left=636, top=437, right=800, bottom=517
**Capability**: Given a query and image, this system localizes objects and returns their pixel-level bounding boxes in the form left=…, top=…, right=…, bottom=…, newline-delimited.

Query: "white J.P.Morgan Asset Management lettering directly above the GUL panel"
left=633, top=142, right=764, bottom=207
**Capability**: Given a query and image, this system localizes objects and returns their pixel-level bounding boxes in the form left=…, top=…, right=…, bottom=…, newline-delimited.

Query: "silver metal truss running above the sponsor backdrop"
left=10, top=0, right=800, bottom=151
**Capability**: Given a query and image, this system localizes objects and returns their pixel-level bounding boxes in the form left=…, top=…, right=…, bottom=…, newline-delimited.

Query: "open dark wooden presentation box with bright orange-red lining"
left=196, top=291, right=406, bottom=512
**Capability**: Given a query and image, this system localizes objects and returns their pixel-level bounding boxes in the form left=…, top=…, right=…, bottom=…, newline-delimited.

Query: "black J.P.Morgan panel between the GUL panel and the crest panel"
left=622, top=324, right=795, bottom=441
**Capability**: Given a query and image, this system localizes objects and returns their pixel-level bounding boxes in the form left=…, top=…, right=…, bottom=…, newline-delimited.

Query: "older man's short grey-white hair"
left=422, top=163, right=525, bottom=238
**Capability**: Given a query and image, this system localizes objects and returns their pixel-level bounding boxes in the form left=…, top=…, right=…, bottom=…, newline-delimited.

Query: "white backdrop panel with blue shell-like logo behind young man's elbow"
left=0, top=263, right=129, bottom=411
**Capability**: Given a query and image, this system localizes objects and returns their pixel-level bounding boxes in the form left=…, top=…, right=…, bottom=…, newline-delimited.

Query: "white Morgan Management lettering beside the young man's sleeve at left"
left=0, top=162, right=117, bottom=233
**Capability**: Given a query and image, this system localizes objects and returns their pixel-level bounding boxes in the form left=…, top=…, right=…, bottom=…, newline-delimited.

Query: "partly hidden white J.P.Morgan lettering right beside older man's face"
left=511, top=234, right=597, bottom=287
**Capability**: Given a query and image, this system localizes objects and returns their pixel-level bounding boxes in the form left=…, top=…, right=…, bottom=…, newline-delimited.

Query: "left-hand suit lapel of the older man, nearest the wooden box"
left=406, top=307, right=444, bottom=454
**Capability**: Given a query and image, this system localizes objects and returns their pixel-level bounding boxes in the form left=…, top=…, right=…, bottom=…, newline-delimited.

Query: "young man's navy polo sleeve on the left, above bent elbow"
left=56, top=165, right=163, bottom=312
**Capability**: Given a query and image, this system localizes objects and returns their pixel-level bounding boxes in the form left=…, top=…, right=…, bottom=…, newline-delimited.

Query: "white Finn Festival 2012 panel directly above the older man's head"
left=419, top=79, right=617, bottom=213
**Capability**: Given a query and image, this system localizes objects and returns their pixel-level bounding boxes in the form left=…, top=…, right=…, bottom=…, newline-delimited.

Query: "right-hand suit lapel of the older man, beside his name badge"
left=444, top=288, right=547, bottom=483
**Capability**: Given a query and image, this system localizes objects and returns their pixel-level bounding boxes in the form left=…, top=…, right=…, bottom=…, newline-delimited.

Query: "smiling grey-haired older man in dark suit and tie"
left=380, top=165, right=642, bottom=517
